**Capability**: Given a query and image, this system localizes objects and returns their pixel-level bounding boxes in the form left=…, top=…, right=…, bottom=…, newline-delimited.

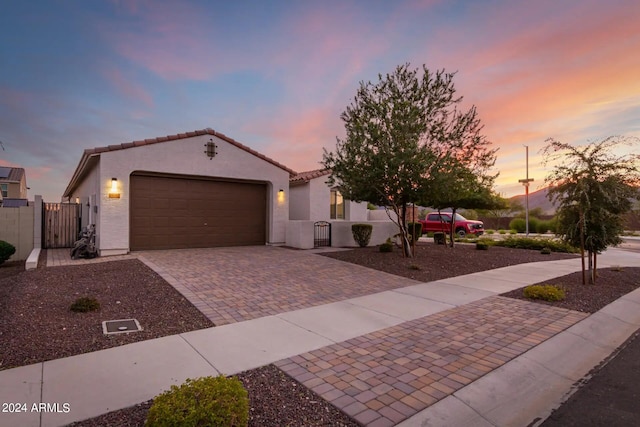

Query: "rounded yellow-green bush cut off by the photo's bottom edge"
left=145, top=375, right=249, bottom=427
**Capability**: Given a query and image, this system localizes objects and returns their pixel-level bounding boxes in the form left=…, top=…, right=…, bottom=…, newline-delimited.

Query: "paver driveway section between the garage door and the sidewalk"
left=135, top=246, right=417, bottom=325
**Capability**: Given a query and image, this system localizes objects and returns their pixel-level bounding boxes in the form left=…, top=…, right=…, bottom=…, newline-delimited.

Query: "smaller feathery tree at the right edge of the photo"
left=543, top=136, right=640, bottom=284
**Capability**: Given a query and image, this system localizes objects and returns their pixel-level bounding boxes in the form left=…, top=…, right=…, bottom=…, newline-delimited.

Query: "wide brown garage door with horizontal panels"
left=130, top=175, right=267, bottom=250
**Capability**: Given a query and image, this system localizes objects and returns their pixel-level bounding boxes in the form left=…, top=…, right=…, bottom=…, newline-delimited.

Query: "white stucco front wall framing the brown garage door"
left=76, top=135, right=290, bottom=255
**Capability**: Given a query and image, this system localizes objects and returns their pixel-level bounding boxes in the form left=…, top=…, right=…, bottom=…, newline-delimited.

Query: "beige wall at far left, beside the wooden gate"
left=0, top=203, right=34, bottom=261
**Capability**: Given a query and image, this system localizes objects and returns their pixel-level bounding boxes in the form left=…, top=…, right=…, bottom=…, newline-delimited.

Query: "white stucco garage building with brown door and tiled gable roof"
left=63, top=129, right=296, bottom=255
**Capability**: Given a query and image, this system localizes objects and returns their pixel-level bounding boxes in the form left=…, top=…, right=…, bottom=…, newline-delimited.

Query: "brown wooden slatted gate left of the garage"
left=42, top=203, right=81, bottom=249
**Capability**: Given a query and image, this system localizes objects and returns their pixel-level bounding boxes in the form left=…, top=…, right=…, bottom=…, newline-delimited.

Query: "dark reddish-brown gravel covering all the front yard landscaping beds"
left=0, top=244, right=640, bottom=426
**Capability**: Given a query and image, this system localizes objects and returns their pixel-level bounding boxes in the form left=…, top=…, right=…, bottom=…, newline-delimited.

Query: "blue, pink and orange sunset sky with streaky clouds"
left=0, top=0, right=640, bottom=202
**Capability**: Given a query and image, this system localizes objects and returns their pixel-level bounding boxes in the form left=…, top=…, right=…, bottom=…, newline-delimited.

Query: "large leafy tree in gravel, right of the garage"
left=322, top=64, right=496, bottom=256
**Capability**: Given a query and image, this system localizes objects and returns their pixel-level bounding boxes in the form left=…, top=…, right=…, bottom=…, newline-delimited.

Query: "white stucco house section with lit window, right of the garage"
left=289, top=169, right=368, bottom=221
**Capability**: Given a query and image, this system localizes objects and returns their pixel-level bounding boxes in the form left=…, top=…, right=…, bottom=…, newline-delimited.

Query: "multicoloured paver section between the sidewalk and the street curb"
left=276, top=296, right=588, bottom=426
